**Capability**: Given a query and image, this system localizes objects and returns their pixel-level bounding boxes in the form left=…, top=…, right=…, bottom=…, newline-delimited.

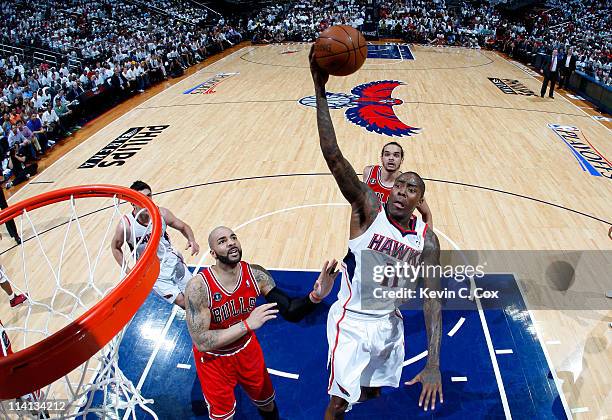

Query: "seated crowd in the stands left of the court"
left=0, top=0, right=242, bottom=188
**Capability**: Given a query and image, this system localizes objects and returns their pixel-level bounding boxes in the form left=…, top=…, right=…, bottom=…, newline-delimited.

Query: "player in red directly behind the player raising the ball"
left=363, top=141, right=433, bottom=228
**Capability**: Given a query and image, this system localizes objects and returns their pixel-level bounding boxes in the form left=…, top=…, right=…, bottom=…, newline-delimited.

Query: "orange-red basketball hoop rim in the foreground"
left=0, top=184, right=162, bottom=400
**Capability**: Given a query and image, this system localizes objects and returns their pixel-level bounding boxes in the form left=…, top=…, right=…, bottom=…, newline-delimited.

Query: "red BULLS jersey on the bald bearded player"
left=194, top=261, right=259, bottom=359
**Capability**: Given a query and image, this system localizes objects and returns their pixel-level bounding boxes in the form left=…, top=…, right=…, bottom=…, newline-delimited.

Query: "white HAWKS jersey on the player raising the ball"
left=338, top=209, right=427, bottom=316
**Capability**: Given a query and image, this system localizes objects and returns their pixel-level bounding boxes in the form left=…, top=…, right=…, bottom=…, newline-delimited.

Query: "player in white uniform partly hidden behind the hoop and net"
left=111, top=181, right=200, bottom=309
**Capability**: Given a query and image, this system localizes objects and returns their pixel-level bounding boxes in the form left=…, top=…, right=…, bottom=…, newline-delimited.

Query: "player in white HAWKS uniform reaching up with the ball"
left=310, top=49, right=442, bottom=419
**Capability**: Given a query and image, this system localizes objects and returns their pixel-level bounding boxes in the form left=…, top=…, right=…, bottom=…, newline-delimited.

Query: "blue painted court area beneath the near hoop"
left=93, top=271, right=566, bottom=420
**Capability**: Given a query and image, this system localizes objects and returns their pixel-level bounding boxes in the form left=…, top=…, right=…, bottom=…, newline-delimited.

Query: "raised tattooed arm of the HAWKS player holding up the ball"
left=309, top=47, right=380, bottom=231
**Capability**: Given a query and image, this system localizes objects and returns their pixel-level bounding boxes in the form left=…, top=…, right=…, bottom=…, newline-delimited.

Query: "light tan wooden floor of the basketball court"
left=0, top=44, right=612, bottom=418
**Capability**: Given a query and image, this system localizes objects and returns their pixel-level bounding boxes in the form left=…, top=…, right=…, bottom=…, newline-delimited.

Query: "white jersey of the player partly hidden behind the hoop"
left=124, top=213, right=182, bottom=278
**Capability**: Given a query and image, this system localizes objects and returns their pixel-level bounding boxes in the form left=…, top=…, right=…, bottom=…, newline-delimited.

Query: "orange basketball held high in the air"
left=315, top=25, right=368, bottom=76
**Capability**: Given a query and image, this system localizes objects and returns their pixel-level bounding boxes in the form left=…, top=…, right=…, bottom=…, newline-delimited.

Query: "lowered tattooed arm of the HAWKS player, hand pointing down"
left=406, top=229, right=444, bottom=411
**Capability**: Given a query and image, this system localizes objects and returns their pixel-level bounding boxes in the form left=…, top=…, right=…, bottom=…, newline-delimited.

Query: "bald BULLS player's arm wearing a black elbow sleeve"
left=251, top=260, right=338, bottom=322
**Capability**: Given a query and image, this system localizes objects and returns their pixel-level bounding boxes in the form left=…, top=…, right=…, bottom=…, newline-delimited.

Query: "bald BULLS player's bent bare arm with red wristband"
left=185, top=276, right=278, bottom=352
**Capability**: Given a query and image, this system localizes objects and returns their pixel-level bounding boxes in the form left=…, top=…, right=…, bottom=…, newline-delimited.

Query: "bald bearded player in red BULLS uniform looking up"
left=185, top=226, right=338, bottom=420
